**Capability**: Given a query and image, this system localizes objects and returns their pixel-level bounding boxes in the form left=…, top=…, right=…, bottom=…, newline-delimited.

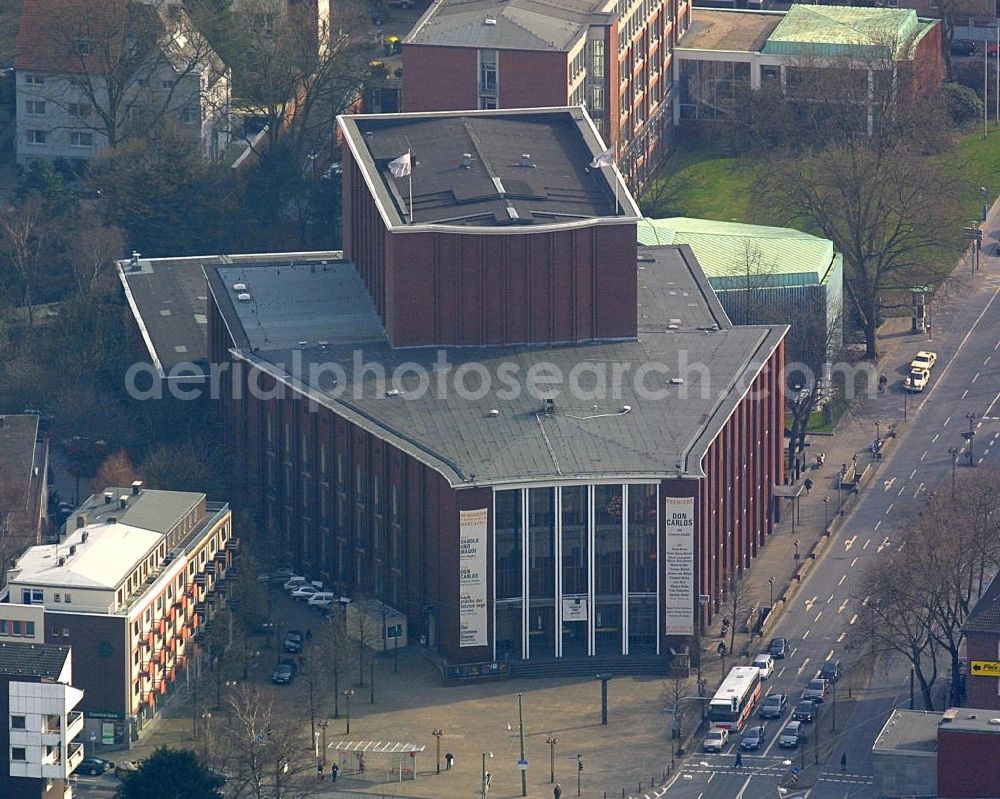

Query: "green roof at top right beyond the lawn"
left=762, top=5, right=933, bottom=59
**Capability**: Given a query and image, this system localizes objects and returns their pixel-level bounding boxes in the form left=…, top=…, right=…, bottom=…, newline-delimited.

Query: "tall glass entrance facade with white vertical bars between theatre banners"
left=493, top=483, right=660, bottom=659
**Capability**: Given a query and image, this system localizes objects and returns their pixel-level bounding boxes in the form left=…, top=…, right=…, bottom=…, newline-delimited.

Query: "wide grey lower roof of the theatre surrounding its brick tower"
left=208, top=247, right=787, bottom=486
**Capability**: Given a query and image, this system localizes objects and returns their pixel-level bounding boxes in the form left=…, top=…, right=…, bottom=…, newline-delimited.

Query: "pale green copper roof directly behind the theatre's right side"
left=638, top=217, right=835, bottom=290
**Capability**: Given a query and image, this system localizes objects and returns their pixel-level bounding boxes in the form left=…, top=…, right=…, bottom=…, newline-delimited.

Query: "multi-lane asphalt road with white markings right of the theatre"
left=666, top=259, right=1000, bottom=799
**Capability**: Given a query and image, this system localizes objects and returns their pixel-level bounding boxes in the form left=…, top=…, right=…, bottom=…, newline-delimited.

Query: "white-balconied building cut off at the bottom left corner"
left=0, top=640, right=84, bottom=799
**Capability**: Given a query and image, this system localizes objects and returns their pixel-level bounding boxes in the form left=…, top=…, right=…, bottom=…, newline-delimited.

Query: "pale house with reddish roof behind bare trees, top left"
left=14, top=0, right=230, bottom=167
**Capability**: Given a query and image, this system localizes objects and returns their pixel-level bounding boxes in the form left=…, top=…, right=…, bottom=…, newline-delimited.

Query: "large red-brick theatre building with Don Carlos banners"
left=199, top=103, right=786, bottom=673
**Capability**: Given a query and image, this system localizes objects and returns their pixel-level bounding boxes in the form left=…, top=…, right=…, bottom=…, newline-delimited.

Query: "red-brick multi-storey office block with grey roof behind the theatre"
left=403, top=0, right=691, bottom=191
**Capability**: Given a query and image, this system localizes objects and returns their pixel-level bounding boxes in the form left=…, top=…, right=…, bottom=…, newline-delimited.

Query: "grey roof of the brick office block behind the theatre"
left=403, top=0, right=614, bottom=51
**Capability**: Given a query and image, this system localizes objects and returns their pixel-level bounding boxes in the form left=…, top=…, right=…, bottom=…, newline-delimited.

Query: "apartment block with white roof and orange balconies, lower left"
left=0, top=481, right=236, bottom=746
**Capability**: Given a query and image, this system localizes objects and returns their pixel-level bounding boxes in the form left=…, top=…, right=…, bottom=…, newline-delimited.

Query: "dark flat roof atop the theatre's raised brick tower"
left=339, top=107, right=639, bottom=232
